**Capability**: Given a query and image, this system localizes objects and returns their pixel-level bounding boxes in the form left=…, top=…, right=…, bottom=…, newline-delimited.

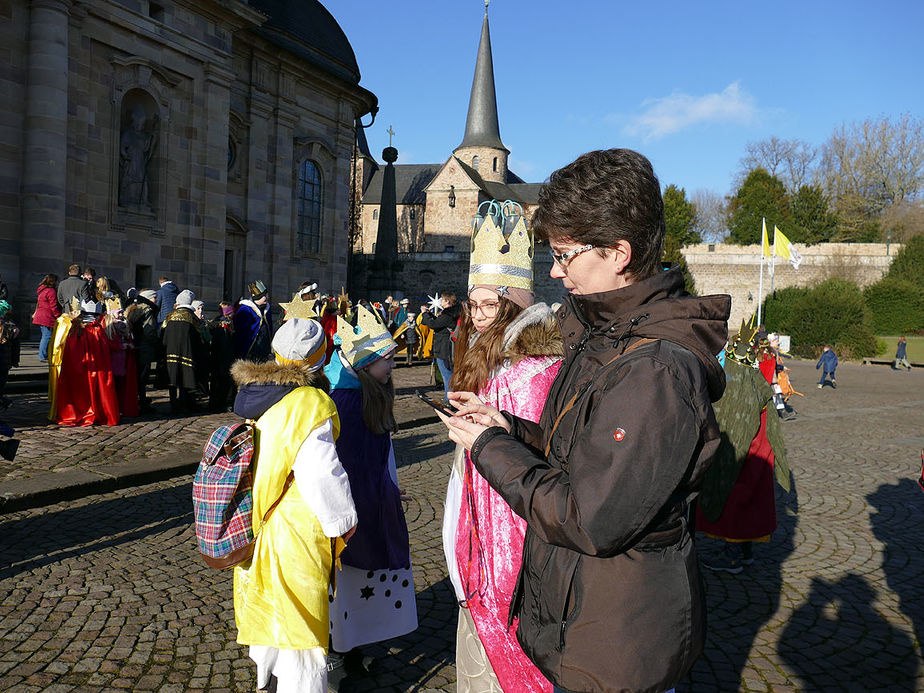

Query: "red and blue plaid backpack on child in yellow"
left=193, top=423, right=295, bottom=570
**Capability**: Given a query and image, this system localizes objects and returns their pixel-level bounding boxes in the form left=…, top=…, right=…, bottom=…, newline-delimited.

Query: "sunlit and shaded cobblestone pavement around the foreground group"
left=0, top=362, right=924, bottom=693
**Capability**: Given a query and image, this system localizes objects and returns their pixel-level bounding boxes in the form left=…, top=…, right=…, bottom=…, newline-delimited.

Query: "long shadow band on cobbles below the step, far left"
left=0, top=483, right=193, bottom=580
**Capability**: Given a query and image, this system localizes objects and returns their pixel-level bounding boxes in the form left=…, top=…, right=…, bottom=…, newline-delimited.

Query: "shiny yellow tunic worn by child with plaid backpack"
left=234, top=387, right=344, bottom=652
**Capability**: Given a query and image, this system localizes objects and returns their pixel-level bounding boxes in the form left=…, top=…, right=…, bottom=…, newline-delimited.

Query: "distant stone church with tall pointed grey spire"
left=351, top=9, right=542, bottom=298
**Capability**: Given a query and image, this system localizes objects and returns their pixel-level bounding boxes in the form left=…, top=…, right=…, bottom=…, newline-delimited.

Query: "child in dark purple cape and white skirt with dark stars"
left=325, top=306, right=417, bottom=665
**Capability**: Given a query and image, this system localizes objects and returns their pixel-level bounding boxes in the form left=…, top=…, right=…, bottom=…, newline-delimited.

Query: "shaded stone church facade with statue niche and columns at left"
left=0, top=0, right=377, bottom=332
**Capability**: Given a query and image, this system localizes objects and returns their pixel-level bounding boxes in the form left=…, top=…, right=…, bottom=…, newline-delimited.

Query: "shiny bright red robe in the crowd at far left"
left=56, top=320, right=122, bottom=426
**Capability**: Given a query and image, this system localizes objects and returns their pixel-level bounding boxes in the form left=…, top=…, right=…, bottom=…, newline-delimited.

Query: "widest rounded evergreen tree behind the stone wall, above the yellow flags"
left=728, top=168, right=789, bottom=245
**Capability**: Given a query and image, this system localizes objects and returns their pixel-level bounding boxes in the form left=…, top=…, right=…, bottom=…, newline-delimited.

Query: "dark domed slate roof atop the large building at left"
left=248, top=0, right=360, bottom=84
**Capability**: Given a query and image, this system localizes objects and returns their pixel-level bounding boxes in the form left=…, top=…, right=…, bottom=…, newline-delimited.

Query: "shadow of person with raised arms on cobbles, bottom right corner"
left=779, top=573, right=917, bottom=692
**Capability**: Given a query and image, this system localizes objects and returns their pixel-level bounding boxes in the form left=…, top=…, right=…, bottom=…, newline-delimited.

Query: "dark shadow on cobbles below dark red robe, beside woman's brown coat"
left=676, top=468, right=799, bottom=693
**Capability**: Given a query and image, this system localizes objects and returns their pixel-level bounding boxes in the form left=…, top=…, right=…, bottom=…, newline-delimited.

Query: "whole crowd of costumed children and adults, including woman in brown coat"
left=9, top=149, right=908, bottom=693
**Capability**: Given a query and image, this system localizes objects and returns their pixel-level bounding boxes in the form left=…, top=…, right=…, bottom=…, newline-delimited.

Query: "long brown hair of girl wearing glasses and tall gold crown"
left=450, top=296, right=523, bottom=393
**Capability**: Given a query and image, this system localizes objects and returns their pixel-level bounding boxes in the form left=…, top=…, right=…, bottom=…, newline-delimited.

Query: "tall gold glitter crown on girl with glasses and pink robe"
left=468, top=200, right=534, bottom=291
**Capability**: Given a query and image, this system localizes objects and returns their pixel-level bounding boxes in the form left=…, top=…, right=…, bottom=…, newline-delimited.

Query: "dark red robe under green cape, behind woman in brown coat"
left=696, top=356, right=776, bottom=541
